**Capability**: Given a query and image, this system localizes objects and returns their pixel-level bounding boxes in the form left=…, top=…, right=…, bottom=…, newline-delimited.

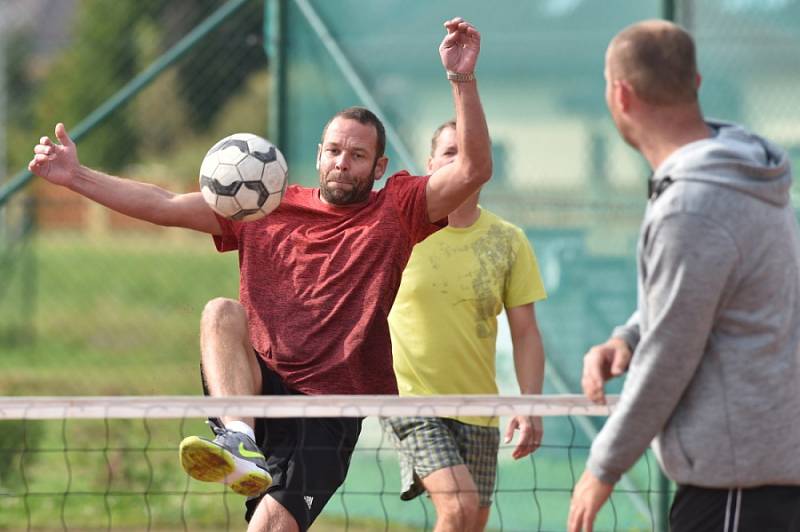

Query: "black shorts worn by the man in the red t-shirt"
left=201, top=357, right=363, bottom=532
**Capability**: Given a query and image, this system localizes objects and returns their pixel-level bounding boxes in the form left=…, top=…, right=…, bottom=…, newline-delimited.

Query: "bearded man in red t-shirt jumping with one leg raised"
left=28, top=18, right=492, bottom=531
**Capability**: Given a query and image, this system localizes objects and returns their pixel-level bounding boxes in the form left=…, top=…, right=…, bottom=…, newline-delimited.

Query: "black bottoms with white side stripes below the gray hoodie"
left=669, top=486, right=800, bottom=532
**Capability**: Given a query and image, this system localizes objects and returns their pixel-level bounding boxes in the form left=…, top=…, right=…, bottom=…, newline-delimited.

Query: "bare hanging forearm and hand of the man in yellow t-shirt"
left=505, top=303, right=544, bottom=460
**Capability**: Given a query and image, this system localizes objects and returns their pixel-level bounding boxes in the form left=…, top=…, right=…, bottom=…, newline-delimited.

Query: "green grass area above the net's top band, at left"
left=0, top=231, right=238, bottom=395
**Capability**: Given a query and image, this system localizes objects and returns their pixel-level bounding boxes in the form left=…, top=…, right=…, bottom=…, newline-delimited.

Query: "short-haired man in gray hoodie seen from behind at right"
left=568, top=21, right=800, bottom=532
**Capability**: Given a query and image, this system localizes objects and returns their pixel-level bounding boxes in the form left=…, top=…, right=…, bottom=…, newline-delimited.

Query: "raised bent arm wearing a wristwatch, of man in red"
left=427, top=18, right=492, bottom=222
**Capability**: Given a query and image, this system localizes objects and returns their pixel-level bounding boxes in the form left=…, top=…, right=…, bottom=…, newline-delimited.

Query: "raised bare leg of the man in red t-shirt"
left=200, top=297, right=261, bottom=427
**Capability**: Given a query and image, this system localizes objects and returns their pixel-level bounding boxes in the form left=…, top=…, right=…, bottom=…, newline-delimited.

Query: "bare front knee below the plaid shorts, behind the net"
left=422, top=464, right=488, bottom=532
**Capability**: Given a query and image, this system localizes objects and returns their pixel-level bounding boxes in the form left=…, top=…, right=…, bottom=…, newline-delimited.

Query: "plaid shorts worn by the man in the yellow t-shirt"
left=381, top=417, right=500, bottom=507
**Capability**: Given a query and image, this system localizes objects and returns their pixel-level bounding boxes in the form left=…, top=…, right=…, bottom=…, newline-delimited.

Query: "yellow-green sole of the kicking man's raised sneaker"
left=180, top=436, right=272, bottom=497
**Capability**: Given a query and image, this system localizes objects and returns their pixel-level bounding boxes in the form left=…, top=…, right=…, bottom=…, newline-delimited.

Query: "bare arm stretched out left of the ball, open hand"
left=28, top=123, right=221, bottom=234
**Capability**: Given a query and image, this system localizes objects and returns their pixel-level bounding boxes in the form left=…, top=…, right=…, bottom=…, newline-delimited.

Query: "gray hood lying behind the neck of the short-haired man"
left=652, top=120, right=792, bottom=206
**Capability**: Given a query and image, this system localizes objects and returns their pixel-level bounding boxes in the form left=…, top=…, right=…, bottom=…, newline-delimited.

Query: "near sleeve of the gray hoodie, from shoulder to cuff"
left=587, top=212, right=739, bottom=483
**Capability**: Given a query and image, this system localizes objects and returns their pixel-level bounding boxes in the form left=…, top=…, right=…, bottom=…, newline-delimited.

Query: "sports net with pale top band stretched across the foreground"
left=0, top=395, right=669, bottom=532
